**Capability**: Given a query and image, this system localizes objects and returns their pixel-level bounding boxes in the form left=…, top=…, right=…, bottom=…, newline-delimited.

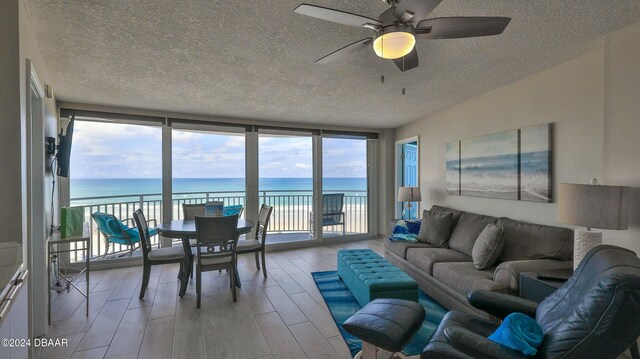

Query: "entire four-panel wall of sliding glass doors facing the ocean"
left=60, top=110, right=380, bottom=261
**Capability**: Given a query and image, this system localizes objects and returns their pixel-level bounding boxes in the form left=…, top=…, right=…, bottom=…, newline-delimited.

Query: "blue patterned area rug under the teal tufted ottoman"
left=311, top=271, right=447, bottom=356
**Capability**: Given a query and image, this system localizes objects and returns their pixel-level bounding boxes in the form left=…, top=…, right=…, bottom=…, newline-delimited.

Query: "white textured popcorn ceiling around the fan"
left=25, top=0, right=640, bottom=128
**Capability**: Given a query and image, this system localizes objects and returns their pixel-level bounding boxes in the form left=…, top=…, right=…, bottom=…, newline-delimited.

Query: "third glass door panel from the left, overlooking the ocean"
left=258, top=133, right=313, bottom=244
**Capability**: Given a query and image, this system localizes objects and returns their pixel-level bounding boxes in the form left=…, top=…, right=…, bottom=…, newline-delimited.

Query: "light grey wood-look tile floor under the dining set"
left=35, top=240, right=416, bottom=359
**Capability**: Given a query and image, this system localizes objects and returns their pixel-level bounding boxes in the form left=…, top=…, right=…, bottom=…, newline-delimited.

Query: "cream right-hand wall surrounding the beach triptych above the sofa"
left=396, top=20, right=640, bottom=252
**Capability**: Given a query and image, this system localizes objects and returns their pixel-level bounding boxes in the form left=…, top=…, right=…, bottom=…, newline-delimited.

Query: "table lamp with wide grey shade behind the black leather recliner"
left=558, top=179, right=630, bottom=270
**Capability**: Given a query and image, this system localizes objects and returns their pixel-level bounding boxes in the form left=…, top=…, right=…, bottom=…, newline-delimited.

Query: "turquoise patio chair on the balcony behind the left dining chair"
left=91, top=212, right=158, bottom=257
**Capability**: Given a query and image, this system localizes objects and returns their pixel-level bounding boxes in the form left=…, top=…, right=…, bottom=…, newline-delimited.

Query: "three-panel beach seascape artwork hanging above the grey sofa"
left=445, top=123, right=552, bottom=202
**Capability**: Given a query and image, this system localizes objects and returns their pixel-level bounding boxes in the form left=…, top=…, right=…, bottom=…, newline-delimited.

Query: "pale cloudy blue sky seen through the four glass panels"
left=71, top=121, right=366, bottom=178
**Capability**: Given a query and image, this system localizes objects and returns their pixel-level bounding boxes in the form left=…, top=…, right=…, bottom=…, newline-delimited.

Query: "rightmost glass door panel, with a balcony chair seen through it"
left=321, top=137, right=369, bottom=238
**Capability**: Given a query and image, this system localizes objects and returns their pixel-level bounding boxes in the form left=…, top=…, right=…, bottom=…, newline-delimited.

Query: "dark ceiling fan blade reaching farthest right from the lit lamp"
left=416, top=16, right=511, bottom=39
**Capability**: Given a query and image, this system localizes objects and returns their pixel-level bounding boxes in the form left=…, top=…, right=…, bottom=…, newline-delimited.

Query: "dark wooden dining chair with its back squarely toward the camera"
left=195, top=215, right=238, bottom=308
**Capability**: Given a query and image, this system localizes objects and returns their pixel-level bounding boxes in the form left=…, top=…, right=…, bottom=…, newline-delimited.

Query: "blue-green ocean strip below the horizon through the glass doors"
left=70, top=178, right=367, bottom=199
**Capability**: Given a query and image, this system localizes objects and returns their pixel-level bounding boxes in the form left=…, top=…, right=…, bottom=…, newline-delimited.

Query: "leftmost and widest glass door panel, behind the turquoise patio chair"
left=69, top=119, right=162, bottom=261
